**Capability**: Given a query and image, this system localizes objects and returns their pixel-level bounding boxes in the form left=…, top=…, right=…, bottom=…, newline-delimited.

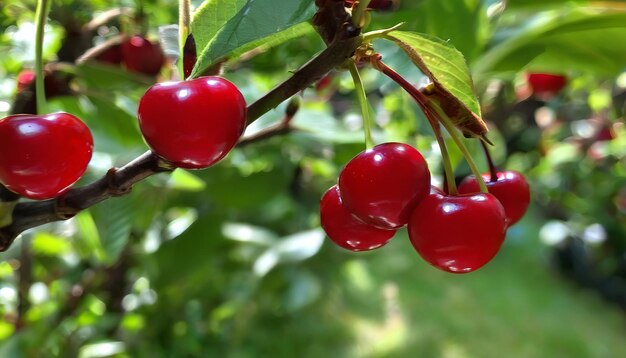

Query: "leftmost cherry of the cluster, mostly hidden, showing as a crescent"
left=320, top=185, right=396, bottom=251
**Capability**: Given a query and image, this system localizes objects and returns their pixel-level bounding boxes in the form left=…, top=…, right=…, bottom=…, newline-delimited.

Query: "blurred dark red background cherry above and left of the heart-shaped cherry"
left=122, top=35, right=165, bottom=76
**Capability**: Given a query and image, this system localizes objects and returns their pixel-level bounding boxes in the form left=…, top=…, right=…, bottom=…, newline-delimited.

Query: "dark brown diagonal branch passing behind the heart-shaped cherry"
left=0, top=21, right=363, bottom=251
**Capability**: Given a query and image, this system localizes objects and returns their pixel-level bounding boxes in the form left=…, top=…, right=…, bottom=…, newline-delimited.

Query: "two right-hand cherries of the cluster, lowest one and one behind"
left=409, top=171, right=530, bottom=273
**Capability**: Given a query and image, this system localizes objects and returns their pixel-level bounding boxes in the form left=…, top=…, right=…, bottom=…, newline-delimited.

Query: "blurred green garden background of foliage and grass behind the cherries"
left=0, top=0, right=626, bottom=357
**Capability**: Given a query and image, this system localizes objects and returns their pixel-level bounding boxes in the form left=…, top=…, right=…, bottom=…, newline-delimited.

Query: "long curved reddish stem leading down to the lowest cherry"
left=372, top=57, right=458, bottom=195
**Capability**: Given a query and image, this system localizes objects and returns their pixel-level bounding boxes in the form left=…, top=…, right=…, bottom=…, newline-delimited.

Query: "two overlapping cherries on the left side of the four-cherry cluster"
left=320, top=143, right=430, bottom=251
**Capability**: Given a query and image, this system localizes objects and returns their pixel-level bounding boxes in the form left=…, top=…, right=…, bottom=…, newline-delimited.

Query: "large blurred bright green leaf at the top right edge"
left=473, top=6, right=626, bottom=78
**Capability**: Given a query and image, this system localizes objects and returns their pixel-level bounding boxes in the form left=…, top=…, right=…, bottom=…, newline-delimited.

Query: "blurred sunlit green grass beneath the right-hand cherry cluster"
left=264, top=204, right=626, bottom=358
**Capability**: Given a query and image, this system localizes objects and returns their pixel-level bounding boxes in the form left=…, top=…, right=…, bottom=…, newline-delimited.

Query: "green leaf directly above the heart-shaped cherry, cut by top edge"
left=191, top=0, right=315, bottom=77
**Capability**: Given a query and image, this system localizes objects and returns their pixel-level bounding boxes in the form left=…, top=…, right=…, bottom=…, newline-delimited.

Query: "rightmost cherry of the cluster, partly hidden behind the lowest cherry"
left=459, top=170, right=530, bottom=226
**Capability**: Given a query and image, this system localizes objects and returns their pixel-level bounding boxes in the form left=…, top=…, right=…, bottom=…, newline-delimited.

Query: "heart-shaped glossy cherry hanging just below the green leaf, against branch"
left=138, top=77, right=246, bottom=169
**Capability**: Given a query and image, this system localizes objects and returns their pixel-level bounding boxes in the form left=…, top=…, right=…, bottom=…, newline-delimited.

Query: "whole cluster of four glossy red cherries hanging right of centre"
left=320, top=143, right=530, bottom=273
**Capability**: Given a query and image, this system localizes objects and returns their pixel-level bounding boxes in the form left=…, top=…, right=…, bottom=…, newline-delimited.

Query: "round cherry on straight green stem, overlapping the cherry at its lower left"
left=339, top=142, right=430, bottom=229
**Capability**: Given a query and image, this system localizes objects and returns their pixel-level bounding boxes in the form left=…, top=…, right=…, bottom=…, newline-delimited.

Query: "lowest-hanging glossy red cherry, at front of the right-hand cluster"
left=408, top=193, right=507, bottom=273
